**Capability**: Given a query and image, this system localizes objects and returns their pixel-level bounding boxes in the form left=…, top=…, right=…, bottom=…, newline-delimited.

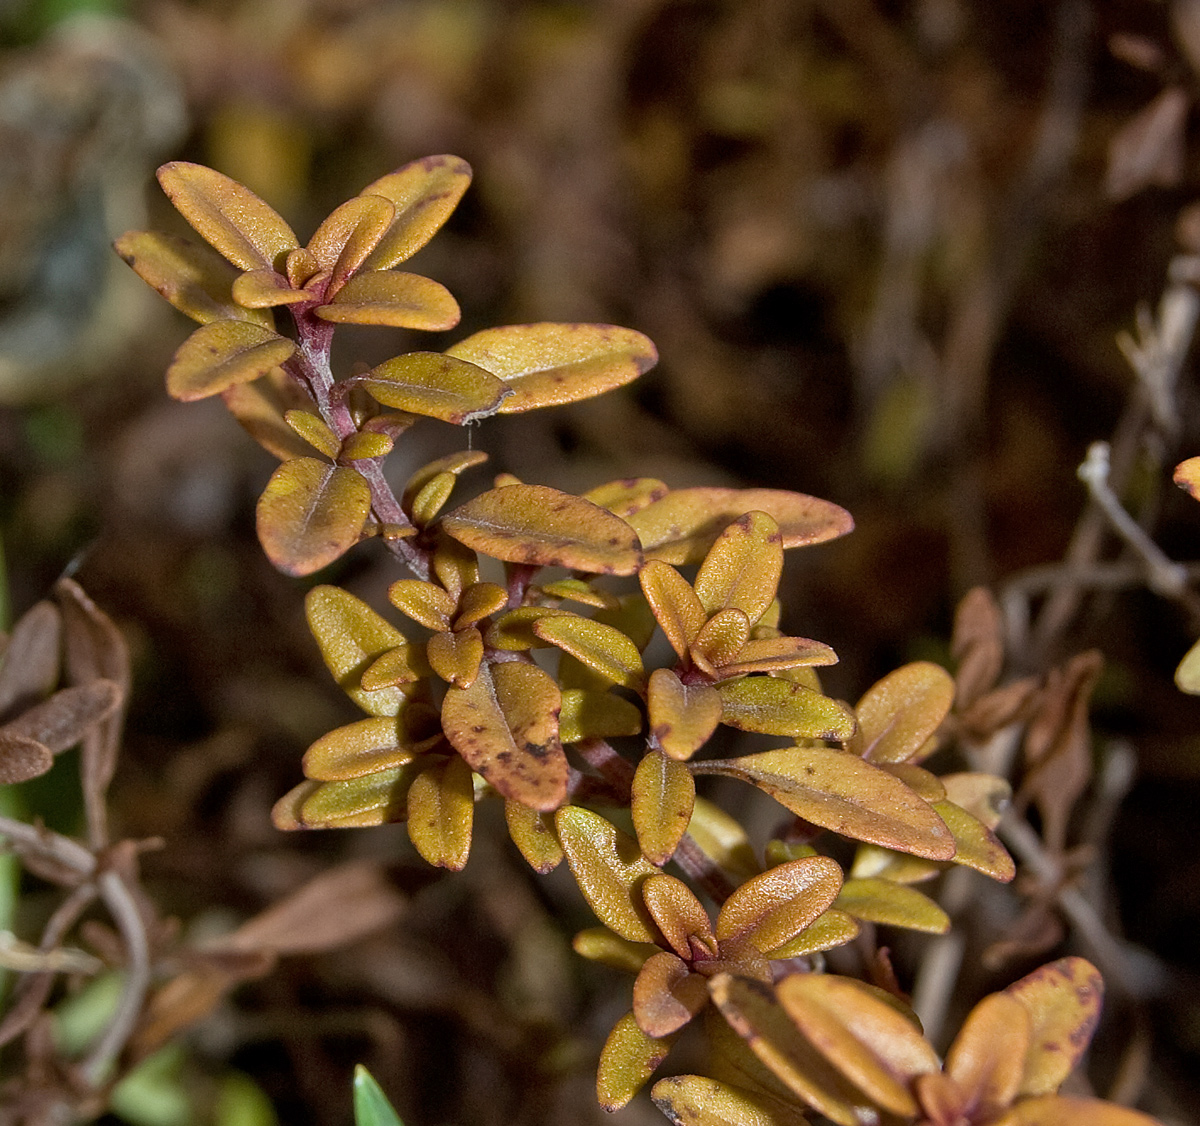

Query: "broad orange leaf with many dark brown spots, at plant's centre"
left=442, top=661, right=566, bottom=810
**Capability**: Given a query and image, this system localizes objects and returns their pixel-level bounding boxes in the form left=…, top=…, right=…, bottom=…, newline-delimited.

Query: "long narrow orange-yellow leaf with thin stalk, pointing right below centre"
left=692, top=747, right=954, bottom=861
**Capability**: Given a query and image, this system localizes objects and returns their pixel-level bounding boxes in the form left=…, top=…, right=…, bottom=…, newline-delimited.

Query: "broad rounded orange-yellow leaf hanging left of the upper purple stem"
left=257, top=457, right=371, bottom=575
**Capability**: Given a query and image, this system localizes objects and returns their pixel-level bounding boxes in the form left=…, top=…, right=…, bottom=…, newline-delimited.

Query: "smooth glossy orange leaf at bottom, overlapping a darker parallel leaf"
left=776, top=974, right=938, bottom=1116
